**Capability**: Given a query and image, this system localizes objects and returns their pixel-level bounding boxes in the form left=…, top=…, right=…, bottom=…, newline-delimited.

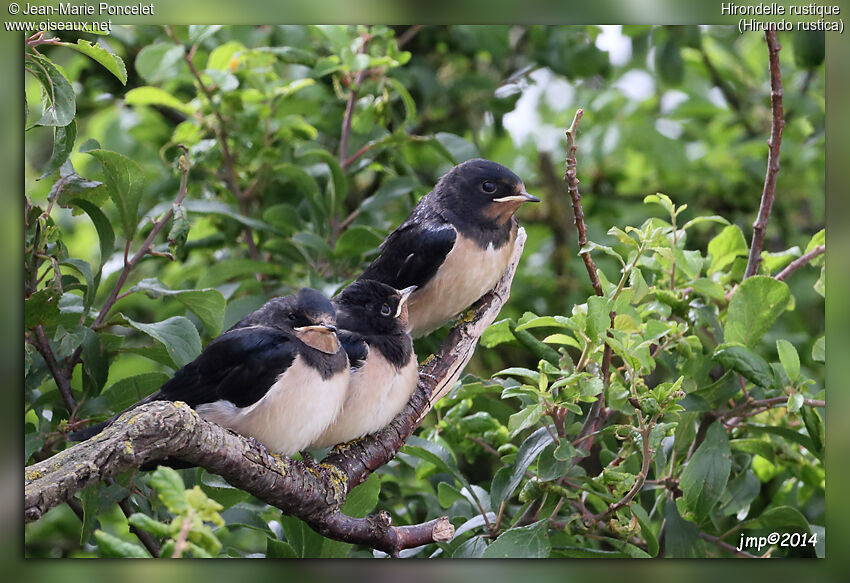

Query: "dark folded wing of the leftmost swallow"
left=160, top=326, right=298, bottom=407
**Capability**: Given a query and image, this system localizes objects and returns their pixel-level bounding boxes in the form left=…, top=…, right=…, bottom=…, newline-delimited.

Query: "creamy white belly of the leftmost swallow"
left=196, top=355, right=350, bottom=455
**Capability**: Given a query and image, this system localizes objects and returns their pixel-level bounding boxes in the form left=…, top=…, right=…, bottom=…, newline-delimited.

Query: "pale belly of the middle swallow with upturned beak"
left=311, top=349, right=419, bottom=448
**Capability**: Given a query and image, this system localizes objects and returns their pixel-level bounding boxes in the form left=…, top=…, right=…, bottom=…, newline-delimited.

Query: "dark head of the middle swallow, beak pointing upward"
left=334, top=279, right=416, bottom=336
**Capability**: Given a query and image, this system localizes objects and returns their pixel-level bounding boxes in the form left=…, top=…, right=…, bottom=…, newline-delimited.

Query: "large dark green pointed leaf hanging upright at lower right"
left=680, top=422, right=732, bottom=520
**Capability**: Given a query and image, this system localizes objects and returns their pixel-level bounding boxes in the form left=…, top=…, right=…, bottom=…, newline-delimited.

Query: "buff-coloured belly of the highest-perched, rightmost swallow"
left=407, top=233, right=516, bottom=338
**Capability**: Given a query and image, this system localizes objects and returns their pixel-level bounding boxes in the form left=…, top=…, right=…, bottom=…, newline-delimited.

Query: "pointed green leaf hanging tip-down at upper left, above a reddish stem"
left=87, top=150, right=145, bottom=240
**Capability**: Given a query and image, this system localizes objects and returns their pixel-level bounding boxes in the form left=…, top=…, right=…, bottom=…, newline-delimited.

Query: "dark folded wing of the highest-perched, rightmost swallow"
left=358, top=222, right=457, bottom=289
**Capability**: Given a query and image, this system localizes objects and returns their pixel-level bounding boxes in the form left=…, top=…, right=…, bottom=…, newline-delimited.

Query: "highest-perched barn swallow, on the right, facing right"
left=359, top=158, right=540, bottom=338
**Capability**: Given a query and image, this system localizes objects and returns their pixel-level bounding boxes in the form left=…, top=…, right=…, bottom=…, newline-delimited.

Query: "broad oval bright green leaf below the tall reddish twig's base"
left=724, top=275, right=791, bottom=346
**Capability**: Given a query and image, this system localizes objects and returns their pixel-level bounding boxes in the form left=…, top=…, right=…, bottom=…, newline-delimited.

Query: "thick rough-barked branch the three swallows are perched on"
left=24, top=229, right=526, bottom=555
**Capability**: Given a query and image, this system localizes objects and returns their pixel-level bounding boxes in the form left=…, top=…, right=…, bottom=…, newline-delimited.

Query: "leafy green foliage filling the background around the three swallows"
left=25, top=26, right=824, bottom=557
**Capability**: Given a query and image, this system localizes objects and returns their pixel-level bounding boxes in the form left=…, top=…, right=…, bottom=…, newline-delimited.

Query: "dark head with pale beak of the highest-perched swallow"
left=434, top=158, right=540, bottom=228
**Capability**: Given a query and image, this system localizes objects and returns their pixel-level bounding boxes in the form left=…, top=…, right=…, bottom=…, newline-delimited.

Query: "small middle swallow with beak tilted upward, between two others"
left=310, top=280, right=419, bottom=449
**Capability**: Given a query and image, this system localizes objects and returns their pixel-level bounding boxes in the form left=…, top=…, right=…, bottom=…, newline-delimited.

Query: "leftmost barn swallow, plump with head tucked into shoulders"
left=71, top=288, right=350, bottom=456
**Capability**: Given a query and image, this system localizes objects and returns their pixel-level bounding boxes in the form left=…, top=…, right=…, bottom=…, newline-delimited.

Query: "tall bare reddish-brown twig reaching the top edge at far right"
left=744, top=30, right=785, bottom=279
